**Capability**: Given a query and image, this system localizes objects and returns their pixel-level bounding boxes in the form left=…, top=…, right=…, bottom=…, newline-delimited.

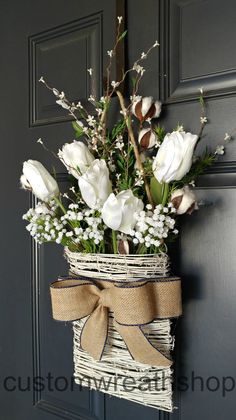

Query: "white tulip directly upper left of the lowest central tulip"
left=79, top=159, right=112, bottom=209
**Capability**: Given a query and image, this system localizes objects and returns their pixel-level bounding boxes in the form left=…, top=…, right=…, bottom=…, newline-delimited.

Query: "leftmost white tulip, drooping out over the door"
left=21, top=160, right=59, bottom=201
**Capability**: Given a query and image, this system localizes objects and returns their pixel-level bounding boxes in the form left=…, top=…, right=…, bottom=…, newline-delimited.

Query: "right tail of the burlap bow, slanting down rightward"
left=115, top=322, right=172, bottom=367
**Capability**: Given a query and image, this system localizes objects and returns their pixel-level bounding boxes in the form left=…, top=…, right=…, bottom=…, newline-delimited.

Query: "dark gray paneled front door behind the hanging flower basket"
left=0, top=0, right=236, bottom=420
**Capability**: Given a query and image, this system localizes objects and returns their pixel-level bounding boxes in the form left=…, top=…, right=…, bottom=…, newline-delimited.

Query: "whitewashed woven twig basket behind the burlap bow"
left=65, top=249, right=174, bottom=412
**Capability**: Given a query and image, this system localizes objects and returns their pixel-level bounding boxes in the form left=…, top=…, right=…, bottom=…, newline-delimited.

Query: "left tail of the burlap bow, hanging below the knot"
left=80, top=305, right=108, bottom=360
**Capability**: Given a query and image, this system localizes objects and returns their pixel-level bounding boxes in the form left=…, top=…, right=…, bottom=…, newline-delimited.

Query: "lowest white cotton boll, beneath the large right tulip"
left=171, top=185, right=198, bottom=214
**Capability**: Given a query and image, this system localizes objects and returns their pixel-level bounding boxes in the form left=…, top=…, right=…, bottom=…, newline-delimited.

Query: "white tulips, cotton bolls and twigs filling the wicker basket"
left=21, top=17, right=231, bottom=254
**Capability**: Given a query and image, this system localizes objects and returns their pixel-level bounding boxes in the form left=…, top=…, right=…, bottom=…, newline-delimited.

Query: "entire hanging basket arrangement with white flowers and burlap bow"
left=20, top=16, right=231, bottom=412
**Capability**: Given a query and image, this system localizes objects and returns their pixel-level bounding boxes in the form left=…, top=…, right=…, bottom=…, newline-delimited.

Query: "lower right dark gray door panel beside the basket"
left=173, top=181, right=236, bottom=420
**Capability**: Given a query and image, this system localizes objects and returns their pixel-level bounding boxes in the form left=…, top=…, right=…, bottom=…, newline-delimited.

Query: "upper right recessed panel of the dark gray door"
left=160, top=0, right=236, bottom=102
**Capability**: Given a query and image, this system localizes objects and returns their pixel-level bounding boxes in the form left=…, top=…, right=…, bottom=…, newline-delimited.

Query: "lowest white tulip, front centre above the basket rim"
left=102, top=190, right=143, bottom=234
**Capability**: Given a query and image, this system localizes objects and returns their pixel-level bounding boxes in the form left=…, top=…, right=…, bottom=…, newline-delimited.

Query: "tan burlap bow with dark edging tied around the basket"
left=50, top=277, right=181, bottom=366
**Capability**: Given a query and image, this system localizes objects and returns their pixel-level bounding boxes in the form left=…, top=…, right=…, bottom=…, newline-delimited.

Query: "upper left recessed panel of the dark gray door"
left=29, top=13, right=102, bottom=126
